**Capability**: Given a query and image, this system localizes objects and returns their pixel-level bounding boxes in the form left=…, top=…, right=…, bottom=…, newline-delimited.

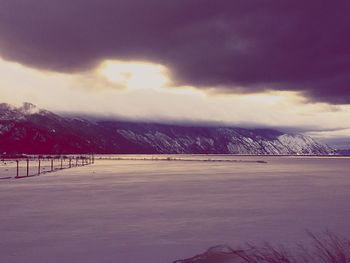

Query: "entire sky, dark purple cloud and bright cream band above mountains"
left=0, top=0, right=350, bottom=145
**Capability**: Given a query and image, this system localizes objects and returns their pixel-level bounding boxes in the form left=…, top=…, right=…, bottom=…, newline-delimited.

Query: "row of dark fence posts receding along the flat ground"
left=15, top=155, right=95, bottom=178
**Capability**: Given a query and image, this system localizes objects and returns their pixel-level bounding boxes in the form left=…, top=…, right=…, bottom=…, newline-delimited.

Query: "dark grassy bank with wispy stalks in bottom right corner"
left=173, top=232, right=350, bottom=263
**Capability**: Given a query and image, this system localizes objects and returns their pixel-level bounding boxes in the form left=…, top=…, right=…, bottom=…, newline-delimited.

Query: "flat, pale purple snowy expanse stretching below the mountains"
left=0, top=156, right=350, bottom=263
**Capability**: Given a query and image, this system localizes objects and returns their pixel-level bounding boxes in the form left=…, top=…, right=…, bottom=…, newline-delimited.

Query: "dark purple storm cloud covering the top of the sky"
left=0, top=0, right=350, bottom=103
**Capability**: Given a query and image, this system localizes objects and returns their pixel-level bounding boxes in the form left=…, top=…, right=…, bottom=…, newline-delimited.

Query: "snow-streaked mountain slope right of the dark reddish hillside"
left=110, top=126, right=334, bottom=155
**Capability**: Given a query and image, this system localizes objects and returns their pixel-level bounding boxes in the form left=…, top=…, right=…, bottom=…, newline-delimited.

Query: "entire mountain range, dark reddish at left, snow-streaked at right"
left=0, top=103, right=335, bottom=155
